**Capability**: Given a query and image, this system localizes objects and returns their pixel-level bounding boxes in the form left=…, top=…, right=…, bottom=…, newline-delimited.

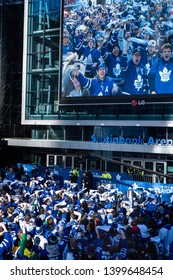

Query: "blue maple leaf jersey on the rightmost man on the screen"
left=149, top=58, right=173, bottom=94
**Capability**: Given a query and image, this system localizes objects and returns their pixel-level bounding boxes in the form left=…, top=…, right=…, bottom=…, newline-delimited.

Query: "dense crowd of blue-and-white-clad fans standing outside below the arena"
left=0, top=164, right=173, bottom=260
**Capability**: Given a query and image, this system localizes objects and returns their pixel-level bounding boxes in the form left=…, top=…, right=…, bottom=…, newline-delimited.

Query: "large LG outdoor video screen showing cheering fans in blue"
left=60, top=0, right=173, bottom=103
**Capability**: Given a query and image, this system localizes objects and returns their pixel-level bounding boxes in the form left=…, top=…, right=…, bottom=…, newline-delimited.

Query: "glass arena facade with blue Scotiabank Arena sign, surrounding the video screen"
left=4, top=0, right=173, bottom=183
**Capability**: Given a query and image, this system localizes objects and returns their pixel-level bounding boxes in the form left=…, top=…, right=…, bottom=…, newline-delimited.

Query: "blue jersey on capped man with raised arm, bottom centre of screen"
left=77, top=73, right=116, bottom=96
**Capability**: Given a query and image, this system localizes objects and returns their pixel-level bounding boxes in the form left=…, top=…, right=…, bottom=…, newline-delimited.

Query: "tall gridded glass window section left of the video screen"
left=25, top=0, right=61, bottom=119
